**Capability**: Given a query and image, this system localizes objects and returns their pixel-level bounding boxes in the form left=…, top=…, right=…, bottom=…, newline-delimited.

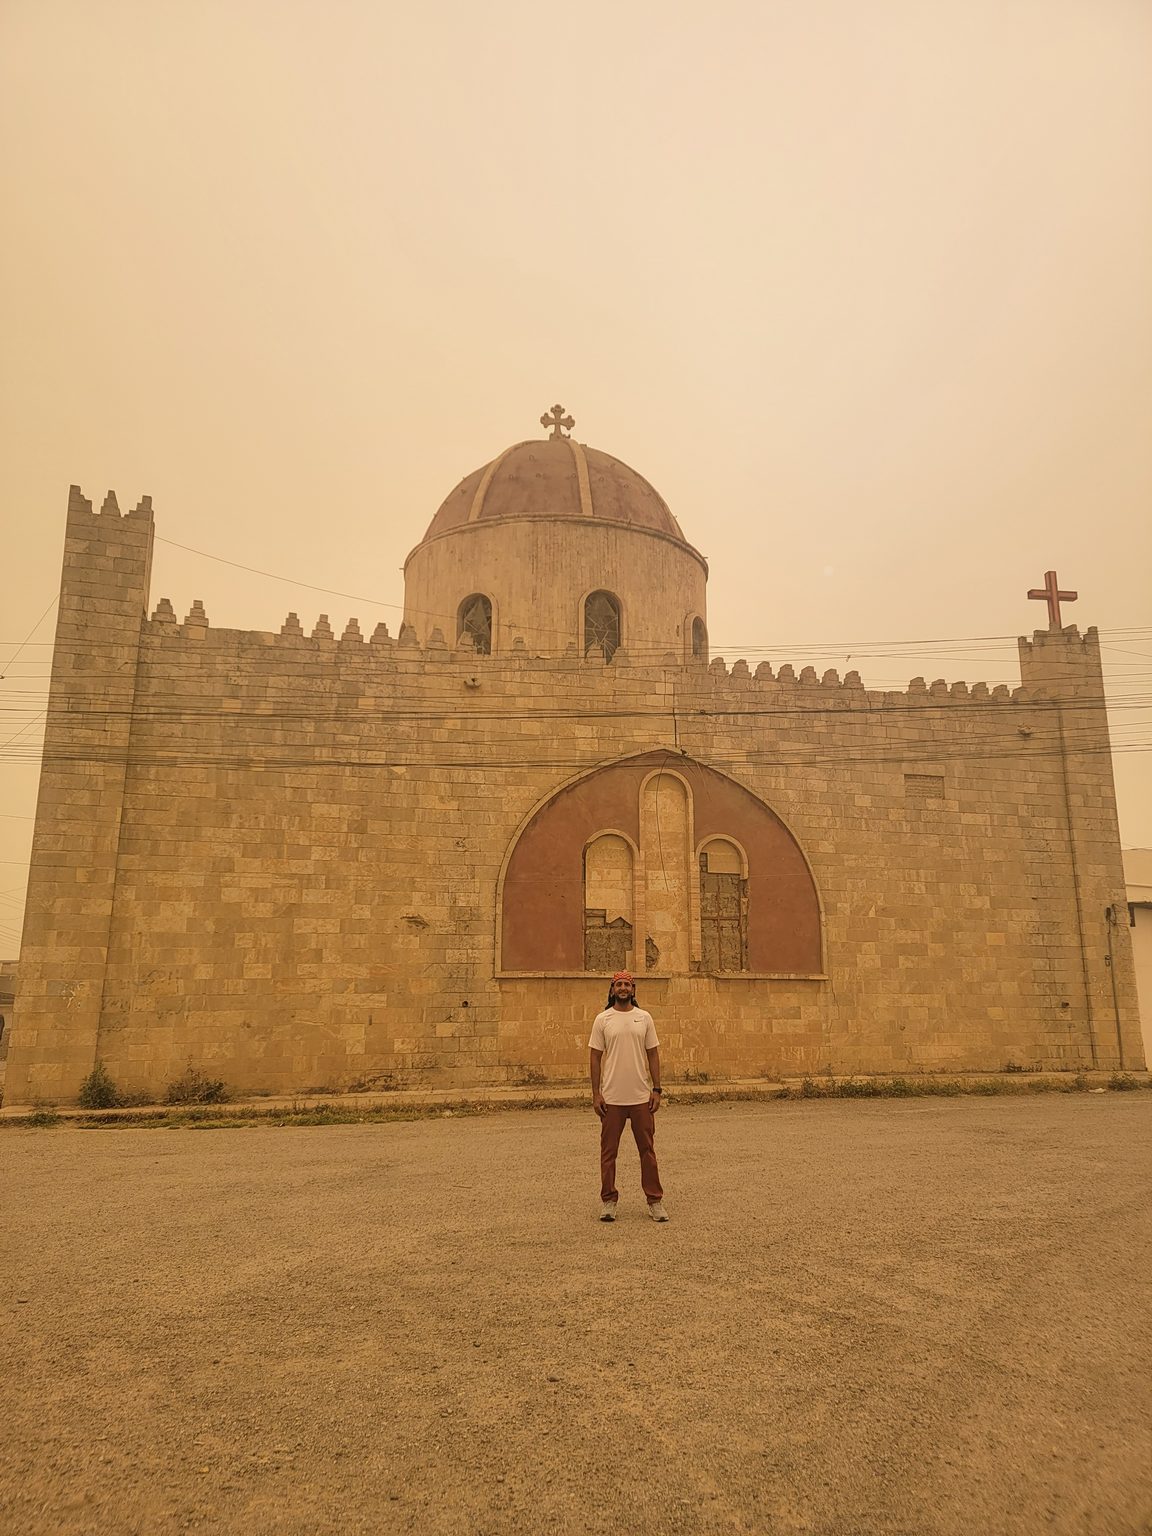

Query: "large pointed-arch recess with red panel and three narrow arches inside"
left=498, top=753, right=823, bottom=977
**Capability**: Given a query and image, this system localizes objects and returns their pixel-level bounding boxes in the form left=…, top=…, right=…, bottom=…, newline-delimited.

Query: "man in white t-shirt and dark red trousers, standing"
left=588, top=971, right=668, bottom=1221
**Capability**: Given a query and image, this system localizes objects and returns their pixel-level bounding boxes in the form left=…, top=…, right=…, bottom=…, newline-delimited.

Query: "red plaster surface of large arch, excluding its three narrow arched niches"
left=496, top=751, right=823, bottom=977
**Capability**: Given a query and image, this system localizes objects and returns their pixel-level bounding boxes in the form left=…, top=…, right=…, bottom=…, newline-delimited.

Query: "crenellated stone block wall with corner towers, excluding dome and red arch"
left=6, top=491, right=1143, bottom=1103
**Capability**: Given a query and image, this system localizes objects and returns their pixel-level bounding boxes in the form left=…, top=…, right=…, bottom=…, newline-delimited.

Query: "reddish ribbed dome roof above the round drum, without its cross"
left=424, top=421, right=700, bottom=544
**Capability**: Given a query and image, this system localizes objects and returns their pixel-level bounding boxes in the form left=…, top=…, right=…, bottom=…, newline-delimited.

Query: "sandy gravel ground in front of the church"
left=0, top=1094, right=1152, bottom=1536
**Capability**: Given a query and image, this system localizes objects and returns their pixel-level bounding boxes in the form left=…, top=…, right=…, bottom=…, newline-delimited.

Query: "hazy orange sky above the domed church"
left=0, top=0, right=1152, bottom=955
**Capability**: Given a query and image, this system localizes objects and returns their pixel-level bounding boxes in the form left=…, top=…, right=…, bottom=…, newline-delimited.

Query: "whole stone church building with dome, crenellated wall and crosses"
left=6, top=407, right=1143, bottom=1104
